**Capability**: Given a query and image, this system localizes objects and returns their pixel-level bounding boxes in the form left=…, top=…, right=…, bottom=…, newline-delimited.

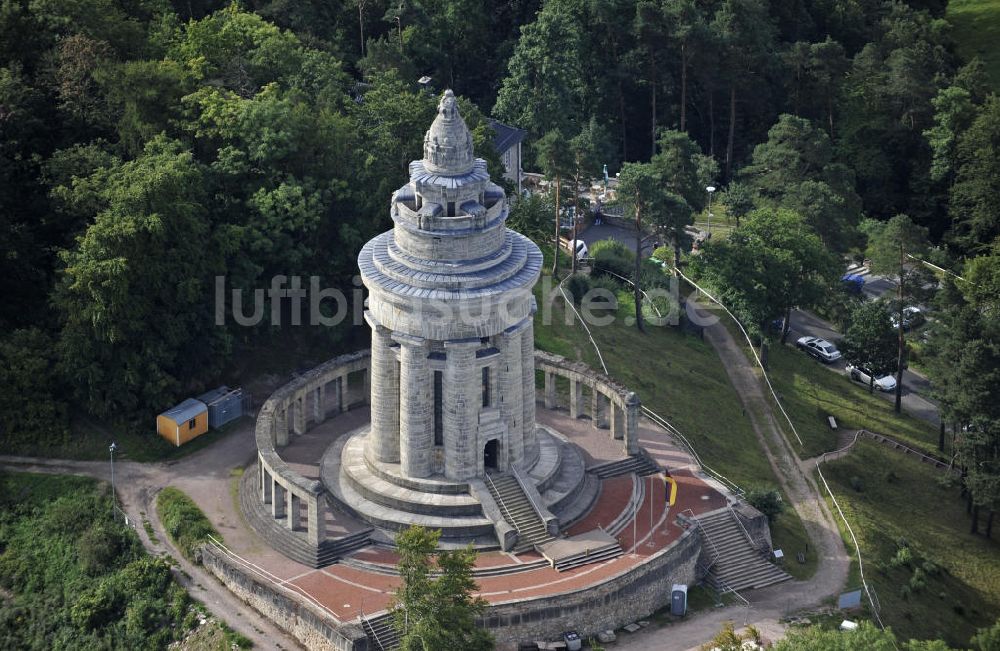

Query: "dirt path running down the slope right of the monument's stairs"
left=617, top=306, right=850, bottom=651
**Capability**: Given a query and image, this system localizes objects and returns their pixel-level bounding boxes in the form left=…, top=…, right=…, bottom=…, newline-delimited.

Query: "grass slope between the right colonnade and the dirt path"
left=535, top=272, right=817, bottom=578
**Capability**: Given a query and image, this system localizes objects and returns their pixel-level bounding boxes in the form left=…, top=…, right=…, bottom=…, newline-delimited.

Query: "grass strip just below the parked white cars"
left=768, top=345, right=938, bottom=458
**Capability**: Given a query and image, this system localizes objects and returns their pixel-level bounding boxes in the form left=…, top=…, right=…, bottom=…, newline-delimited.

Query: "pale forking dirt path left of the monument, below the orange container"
left=0, top=426, right=302, bottom=649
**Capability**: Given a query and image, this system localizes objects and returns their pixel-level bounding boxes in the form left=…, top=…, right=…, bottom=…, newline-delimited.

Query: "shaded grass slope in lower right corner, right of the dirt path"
left=823, top=441, right=1000, bottom=646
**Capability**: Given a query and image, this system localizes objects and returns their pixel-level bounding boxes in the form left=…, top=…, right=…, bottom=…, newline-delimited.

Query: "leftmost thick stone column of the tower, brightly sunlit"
left=368, top=312, right=399, bottom=463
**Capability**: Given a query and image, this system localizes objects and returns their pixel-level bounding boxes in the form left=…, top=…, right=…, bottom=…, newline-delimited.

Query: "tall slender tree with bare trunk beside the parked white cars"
left=863, top=215, right=927, bottom=413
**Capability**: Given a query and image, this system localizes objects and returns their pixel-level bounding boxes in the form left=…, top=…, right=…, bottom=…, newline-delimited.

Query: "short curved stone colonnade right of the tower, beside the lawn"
left=535, top=350, right=642, bottom=454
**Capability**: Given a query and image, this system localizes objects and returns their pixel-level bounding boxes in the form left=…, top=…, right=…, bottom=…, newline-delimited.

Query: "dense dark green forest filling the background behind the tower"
left=0, top=0, right=1000, bottom=464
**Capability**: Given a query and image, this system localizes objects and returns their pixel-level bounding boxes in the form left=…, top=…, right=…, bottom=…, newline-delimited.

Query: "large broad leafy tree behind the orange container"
left=55, top=137, right=227, bottom=418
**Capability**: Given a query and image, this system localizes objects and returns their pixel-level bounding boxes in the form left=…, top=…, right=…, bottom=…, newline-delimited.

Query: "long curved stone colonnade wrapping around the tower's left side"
left=254, top=350, right=370, bottom=546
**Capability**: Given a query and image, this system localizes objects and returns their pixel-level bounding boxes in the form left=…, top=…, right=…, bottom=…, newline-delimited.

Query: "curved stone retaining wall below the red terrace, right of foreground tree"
left=483, top=530, right=701, bottom=646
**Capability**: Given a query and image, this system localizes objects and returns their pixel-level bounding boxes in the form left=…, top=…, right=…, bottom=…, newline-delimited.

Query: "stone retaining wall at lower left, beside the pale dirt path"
left=199, top=544, right=369, bottom=651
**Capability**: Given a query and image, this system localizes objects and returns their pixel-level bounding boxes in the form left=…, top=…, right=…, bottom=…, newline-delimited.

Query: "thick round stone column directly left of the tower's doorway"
left=442, top=339, right=482, bottom=481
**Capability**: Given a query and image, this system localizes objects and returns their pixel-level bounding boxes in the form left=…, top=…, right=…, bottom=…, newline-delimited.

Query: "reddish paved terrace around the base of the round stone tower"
left=212, top=408, right=727, bottom=622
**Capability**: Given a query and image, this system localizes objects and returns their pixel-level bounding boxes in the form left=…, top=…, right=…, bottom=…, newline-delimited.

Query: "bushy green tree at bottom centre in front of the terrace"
left=391, top=526, right=493, bottom=651
